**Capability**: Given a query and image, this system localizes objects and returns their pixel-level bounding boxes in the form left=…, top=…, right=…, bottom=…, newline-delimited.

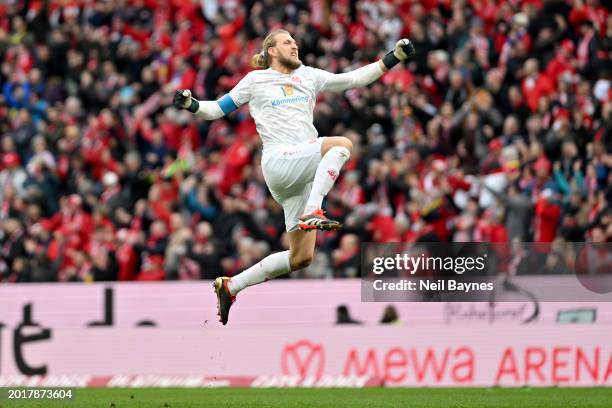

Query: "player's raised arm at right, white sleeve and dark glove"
left=322, top=38, right=415, bottom=91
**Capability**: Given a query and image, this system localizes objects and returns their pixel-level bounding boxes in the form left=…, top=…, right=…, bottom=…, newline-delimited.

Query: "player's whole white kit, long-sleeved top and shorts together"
left=208, top=62, right=383, bottom=231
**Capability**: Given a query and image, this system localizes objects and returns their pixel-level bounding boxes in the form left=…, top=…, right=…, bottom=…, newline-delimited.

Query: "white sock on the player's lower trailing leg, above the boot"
left=228, top=251, right=291, bottom=295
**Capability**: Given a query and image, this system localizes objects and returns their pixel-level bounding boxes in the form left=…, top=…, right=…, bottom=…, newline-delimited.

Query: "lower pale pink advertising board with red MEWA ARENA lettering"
left=0, top=323, right=612, bottom=386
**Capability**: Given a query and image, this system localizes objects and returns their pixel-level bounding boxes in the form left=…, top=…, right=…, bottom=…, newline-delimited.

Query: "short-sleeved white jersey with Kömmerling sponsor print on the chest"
left=229, top=65, right=334, bottom=150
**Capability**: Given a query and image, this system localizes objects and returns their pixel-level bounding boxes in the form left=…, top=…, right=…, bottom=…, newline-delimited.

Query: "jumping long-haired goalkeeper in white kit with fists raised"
left=174, top=30, right=415, bottom=325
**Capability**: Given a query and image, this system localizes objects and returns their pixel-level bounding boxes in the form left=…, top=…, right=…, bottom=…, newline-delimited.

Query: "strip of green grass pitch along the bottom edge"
left=0, top=388, right=612, bottom=408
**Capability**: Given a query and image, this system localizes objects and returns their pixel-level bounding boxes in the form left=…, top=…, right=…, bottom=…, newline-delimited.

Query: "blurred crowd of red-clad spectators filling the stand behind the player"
left=0, top=0, right=612, bottom=282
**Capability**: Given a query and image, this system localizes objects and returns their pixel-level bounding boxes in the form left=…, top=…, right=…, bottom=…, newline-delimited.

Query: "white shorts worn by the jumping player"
left=261, top=137, right=323, bottom=231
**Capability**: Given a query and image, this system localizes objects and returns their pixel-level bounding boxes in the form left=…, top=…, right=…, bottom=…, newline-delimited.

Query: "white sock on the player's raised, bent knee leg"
left=304, top=146, right=351, bottom=214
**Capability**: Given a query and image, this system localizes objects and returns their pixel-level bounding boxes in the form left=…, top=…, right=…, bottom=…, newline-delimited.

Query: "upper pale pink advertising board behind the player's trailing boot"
left=0, top=277, right=612, bottom=329
